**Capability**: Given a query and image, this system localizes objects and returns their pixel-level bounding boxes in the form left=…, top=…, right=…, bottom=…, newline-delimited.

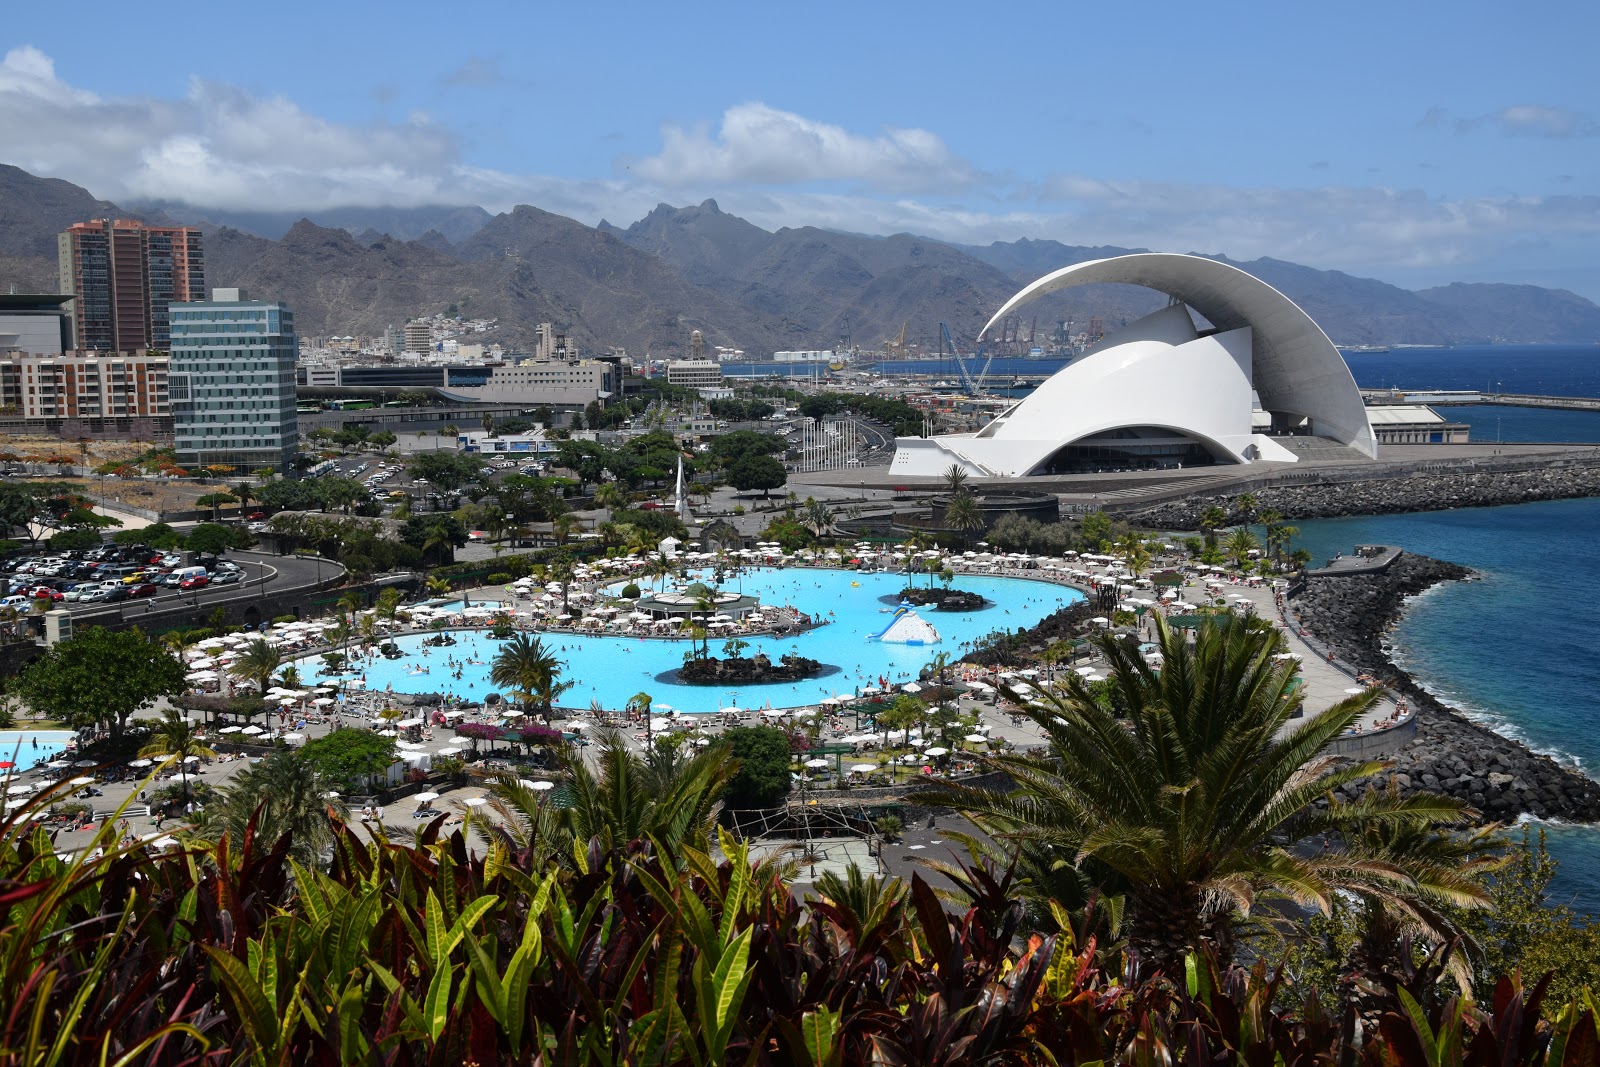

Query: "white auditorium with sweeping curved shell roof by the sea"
left=891, top=253, right=1378, bottom=478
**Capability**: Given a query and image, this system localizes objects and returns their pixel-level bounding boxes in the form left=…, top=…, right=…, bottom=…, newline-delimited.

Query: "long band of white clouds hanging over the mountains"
left=0, top=46, right=1600, bottom=292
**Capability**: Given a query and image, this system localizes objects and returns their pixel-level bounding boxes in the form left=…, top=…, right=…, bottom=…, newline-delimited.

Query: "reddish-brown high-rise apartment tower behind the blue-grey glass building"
left=58, top=219, right=205, bottom=352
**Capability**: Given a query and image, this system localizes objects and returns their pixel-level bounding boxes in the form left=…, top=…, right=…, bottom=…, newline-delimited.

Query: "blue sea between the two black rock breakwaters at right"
left=1299, top=499, right=1600, bottom=915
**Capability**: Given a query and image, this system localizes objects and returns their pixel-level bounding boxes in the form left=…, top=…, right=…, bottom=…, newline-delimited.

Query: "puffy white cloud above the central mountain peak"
left=630, top=102, right=979, bottom=192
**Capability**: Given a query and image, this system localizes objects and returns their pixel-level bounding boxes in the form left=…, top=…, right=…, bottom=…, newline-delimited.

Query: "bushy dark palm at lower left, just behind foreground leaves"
left=195, top=752, right=349, bottom=865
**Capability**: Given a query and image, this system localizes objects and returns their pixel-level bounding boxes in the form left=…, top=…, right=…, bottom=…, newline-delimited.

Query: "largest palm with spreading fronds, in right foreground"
left=925, top=616, right=1475, bottom=974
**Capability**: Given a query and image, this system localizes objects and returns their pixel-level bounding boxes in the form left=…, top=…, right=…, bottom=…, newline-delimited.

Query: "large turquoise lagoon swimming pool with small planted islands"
left=302, top=568, right=1083, bottom=712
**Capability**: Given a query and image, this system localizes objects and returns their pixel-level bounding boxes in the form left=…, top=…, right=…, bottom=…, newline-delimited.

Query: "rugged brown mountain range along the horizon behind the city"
left=0, top=165, right=1600, bottom=357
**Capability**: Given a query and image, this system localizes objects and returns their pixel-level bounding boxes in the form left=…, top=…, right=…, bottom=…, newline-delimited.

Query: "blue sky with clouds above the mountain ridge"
left=0, top=0, right=1600, bottom=299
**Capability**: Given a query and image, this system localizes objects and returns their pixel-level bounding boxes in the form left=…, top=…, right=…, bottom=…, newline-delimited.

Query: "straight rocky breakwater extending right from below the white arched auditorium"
left=1136, top=467, right=1600, bottom=530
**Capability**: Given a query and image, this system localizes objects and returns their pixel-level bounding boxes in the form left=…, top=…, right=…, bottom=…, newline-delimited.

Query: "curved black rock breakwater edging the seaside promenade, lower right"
left=1290, top=553, right=1600, bottom=822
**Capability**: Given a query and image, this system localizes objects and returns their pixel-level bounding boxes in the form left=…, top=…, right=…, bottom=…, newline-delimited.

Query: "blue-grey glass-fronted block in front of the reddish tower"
left=168, top=290, right=299, bottom=472
